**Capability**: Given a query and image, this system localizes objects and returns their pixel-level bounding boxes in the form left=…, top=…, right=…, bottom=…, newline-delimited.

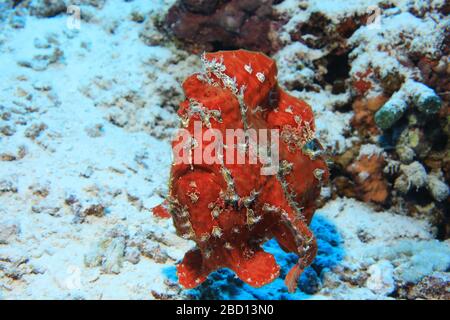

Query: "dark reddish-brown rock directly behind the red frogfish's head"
left=166, top=0, right=279, bottom=53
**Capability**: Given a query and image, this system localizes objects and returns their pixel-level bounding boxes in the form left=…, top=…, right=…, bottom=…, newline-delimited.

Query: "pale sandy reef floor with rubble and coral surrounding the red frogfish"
left=0, top=0, right=450, bottom=299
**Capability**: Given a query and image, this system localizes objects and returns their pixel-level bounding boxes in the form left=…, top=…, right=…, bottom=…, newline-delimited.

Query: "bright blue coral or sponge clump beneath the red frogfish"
left=166, top=214, right=344, bottom=300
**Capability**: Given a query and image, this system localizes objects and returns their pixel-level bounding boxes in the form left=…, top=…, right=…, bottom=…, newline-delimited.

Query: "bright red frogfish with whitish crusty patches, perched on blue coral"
left=157, top=50, right=328, bottom=291
